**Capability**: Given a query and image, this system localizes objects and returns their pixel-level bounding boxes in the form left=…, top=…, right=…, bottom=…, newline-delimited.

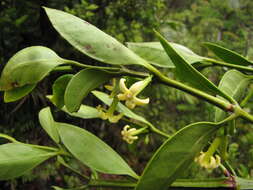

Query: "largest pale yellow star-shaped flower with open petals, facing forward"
left=117, top=77, right=151, bottom=109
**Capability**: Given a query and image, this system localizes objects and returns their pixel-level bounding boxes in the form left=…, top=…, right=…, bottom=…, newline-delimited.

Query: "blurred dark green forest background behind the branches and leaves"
left=0, top=0, right=253, bottom=190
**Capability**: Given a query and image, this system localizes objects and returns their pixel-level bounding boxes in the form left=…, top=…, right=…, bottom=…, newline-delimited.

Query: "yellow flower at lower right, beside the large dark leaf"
left=195, top=152, right=221, bottom=170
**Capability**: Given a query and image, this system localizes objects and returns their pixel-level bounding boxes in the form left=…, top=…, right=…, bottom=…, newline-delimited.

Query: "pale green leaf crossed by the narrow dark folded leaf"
left=127, top=42, right=204, bottom=68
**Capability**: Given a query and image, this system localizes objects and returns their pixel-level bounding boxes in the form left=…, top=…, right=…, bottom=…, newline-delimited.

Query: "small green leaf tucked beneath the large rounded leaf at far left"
left=4, top=84, right=36, bottom=103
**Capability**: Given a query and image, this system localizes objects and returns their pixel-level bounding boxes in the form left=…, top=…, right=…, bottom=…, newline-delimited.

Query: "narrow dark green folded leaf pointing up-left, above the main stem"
left=156, top=30, right=230, bottom=99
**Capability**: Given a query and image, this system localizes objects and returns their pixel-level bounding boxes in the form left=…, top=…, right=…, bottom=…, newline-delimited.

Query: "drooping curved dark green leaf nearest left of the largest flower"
left=64, top=69, right=112, bottom=112
